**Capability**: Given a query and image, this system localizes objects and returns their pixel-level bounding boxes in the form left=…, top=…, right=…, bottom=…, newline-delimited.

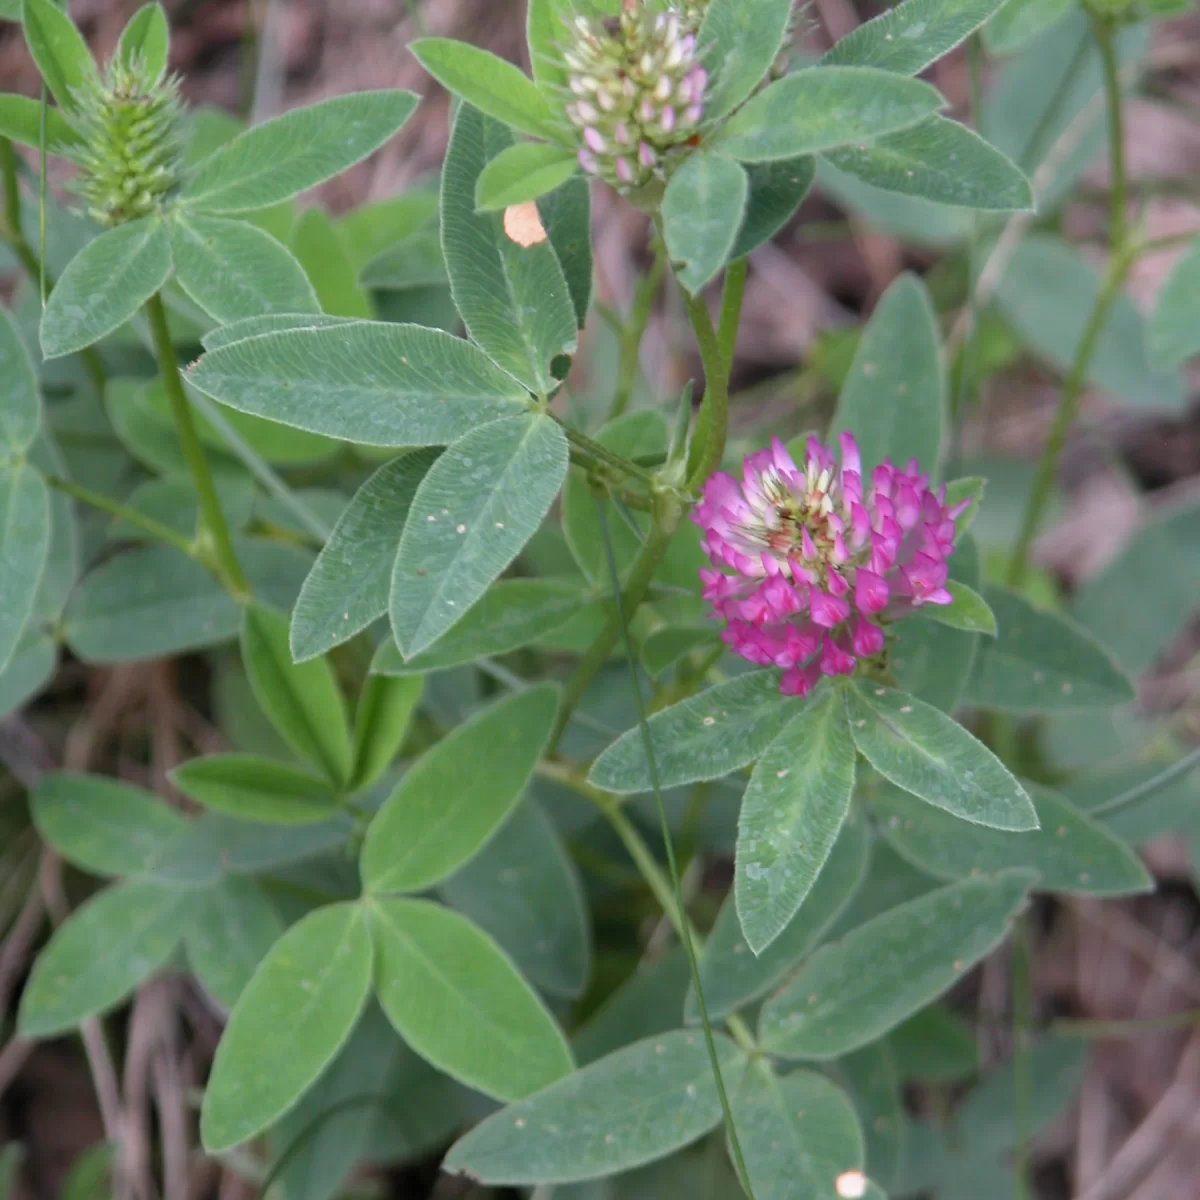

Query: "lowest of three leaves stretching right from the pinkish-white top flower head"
left=827, top=116, right=1034, bottom=212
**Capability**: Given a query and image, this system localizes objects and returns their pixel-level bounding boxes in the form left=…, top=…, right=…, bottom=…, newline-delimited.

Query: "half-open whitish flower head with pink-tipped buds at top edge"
left=563, top=4, right=708, bottom=192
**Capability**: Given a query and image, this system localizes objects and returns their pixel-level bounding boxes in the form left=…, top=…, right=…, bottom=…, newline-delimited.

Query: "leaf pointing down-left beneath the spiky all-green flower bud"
left=41, top=217, right=170, bottom=359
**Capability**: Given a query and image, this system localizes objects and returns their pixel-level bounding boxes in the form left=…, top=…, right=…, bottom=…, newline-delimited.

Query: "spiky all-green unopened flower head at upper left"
left=73, top=59, right=184, bottom=226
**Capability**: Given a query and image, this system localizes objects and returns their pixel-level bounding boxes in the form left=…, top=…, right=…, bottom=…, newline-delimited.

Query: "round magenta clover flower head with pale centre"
left=691, top=433, right=970, bottom=696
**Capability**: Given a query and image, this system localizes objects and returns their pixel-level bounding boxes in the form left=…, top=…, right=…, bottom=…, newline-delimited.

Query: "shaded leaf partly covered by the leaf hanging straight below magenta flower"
left=684, top=811, right=870, bottom=1025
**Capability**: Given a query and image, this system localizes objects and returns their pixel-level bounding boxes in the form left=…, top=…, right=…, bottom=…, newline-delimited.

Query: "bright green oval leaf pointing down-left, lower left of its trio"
left=200, top=904, right=372, bottom=1154
